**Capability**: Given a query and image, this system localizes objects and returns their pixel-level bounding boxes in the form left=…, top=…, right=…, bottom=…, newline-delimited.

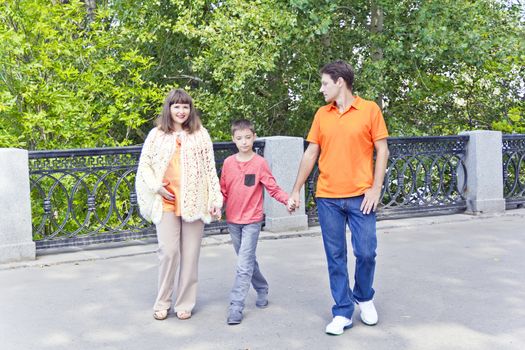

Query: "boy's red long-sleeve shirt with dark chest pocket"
left=221, top=154, right=288, bottom=224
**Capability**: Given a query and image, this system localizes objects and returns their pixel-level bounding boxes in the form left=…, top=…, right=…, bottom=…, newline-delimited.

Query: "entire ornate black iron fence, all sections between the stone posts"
left=29, top=135, right=478, bottom=249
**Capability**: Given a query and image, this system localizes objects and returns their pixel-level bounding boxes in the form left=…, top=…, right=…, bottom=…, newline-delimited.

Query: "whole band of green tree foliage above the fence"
left=0, top=0, right=525, bottom=149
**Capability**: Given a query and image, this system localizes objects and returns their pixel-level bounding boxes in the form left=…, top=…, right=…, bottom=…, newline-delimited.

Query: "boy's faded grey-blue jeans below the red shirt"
left=228, top=222, right=268, bottom=310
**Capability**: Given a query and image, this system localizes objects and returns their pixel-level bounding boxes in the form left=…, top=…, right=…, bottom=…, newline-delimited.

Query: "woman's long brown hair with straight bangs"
left=157, top=89, right=202, bottom=134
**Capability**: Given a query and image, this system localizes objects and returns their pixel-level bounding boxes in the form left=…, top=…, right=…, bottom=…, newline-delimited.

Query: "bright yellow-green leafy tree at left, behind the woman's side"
left=0, top=0, right=161, bottom=149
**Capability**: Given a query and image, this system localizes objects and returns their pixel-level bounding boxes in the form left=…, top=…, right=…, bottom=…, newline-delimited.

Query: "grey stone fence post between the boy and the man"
left=258, top=136, right=308, bottom=232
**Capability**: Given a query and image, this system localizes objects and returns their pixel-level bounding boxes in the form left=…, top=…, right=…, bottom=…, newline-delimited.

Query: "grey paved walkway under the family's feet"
left=0, top=209, right=525, bottom=350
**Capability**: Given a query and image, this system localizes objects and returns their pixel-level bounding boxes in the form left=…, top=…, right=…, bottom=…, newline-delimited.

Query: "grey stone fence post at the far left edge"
left=0, top=148, right=36, bottom=263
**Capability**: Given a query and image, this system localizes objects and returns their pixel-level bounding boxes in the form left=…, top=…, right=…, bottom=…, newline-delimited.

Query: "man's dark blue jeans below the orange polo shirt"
left=316, top=195, right=377, bottom=318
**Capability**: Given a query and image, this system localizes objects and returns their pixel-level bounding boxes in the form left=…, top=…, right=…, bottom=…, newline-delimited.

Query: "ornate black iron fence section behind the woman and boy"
left=29, top=141, right=264, bottom=249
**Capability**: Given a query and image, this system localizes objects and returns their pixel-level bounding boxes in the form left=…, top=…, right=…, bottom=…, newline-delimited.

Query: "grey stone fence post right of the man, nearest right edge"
left=461, top=130, right=505, bottom=213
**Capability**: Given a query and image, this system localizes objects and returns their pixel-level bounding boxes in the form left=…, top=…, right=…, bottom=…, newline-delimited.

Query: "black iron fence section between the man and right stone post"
left=305, top=136, right=469, bottom=223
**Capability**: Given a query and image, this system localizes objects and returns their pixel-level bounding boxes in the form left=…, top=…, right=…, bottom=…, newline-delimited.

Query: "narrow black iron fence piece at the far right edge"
left=503, top=134, right=525, bottom=209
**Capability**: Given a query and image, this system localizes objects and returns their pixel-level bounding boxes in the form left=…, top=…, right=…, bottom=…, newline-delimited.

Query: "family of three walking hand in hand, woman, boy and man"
left=136, top=61, right=388, bottom=335
